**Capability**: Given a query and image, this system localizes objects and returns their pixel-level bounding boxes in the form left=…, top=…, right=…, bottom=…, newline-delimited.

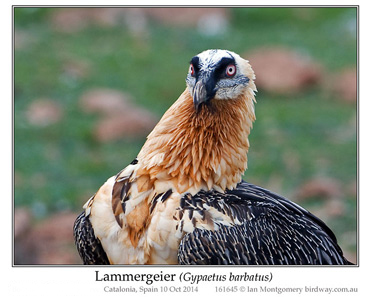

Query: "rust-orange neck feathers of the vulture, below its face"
left=137, top=88, right=255, bottom=193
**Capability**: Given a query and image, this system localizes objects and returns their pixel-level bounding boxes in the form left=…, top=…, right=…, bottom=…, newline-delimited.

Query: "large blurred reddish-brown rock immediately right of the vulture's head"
left=247, top=47, right=322, bottom=95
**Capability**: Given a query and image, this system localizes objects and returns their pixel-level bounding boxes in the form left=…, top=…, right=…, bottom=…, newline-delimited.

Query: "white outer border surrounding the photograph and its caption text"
left=0, top=1, right=371, bottom=297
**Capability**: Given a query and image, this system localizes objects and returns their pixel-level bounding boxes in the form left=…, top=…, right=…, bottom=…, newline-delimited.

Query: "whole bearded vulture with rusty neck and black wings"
left=74, top=50, right=351, bottom=265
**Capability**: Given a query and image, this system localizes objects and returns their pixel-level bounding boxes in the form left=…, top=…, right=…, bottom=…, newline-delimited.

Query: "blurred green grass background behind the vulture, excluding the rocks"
left=14, top=7, right=357, bottom=252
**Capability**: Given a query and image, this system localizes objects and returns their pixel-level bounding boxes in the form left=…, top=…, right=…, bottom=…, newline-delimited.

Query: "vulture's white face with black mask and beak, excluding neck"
left=186, top=49, right=256, bottom=111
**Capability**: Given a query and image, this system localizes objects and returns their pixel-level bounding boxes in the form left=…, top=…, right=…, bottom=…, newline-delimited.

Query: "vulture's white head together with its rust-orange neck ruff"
left=137, top=50, right=256, bottom=194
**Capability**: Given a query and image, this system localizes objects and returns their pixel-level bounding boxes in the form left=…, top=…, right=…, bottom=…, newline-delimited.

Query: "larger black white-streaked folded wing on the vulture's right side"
left=178, top=182, right=351, bottom=265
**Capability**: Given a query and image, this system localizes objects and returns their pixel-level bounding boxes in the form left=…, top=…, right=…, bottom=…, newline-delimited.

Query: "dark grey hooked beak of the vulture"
left=193, top=75, right=216, bottom=112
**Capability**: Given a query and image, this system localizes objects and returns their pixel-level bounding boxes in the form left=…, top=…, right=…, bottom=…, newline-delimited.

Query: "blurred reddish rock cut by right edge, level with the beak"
left=324, top=68, right=357, bottom=103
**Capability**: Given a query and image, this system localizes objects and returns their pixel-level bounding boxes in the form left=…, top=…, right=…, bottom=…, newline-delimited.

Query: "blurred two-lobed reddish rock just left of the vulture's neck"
left=80, top=89, right=157, bottom=142
